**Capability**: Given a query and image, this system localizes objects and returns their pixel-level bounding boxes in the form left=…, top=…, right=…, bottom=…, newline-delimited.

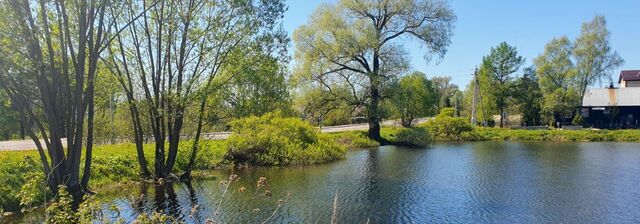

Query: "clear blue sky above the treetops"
left=283, top=0, right=640, bottom=87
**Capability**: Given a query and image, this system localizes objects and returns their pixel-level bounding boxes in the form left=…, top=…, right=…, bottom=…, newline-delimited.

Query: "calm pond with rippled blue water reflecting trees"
left=7, top=142, right=640, bottom=223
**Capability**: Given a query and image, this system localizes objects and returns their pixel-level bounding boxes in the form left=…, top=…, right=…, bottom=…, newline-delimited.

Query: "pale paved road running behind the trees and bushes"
left=0, top=119, right=426, bottom=151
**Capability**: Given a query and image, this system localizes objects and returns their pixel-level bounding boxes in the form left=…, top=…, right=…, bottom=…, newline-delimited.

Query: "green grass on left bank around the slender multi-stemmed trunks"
left=0, top=141, right=227, bottom=212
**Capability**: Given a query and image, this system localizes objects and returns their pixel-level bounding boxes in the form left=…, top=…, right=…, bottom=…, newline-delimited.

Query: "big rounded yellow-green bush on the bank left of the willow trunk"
left=227, top=113, right=346, bottom=166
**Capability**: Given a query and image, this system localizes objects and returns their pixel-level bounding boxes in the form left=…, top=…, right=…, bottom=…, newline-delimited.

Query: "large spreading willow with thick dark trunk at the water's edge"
left=294, top=0, right=456, bottom=143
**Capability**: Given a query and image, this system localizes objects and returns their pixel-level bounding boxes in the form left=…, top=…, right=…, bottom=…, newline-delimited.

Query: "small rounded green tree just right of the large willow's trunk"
left=389, top=72, right=438, bottom=127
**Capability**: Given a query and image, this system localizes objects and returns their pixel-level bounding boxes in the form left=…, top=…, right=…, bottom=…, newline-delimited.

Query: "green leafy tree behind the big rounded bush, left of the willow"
left=207, top=35, right=292, bottom=122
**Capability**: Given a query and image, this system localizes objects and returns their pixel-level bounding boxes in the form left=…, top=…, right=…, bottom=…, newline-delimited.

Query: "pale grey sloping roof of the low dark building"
left=582, top=88, right=640, bottom=107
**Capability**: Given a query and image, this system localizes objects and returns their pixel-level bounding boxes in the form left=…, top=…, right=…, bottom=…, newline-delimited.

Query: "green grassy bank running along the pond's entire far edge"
left=0, top=124, right=640, bottom=212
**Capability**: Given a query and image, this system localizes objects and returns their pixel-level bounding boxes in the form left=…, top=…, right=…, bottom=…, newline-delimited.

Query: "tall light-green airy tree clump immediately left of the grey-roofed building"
left=534, top=15, right=624, bottom=122
